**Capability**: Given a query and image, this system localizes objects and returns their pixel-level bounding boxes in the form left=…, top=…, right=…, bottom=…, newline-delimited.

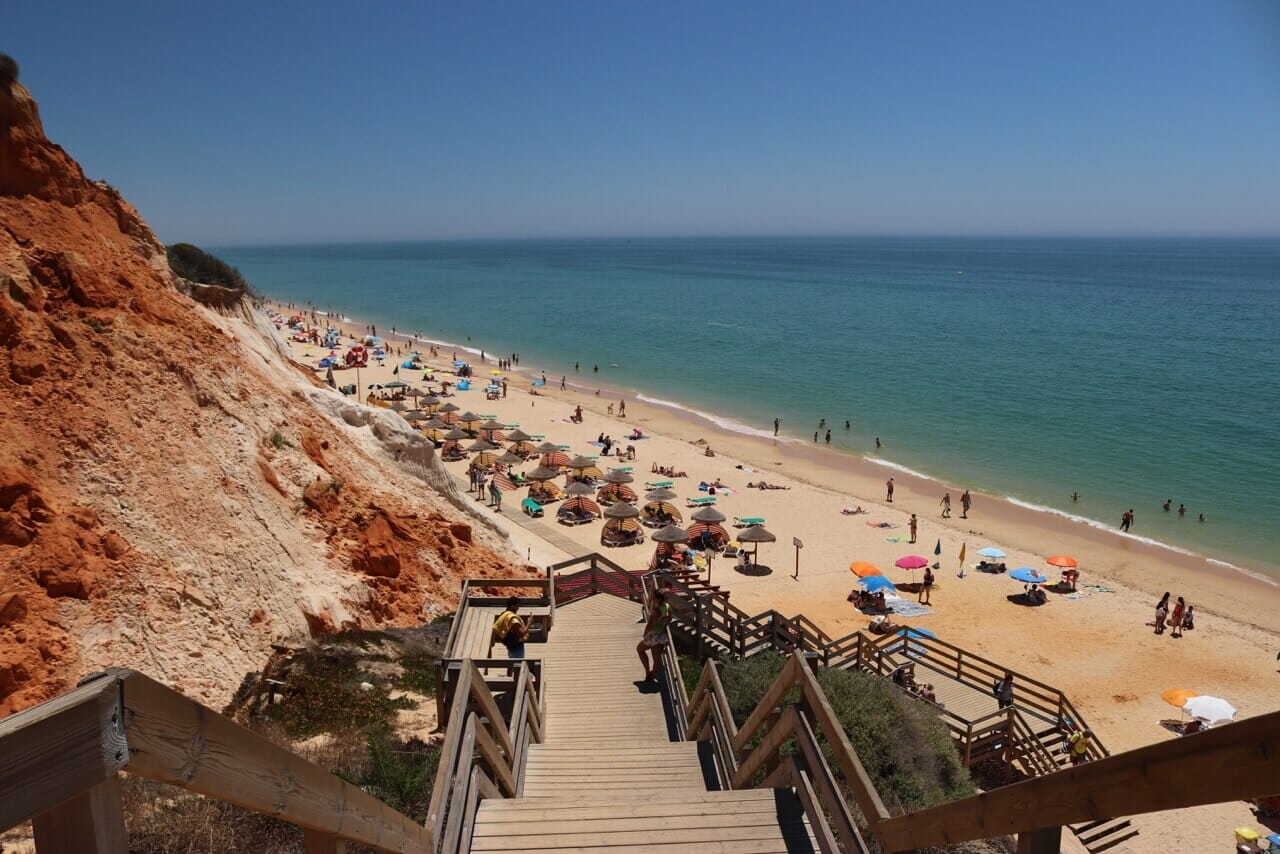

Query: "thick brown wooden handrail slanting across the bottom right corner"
left=878, top=712, right=1280, bottom=851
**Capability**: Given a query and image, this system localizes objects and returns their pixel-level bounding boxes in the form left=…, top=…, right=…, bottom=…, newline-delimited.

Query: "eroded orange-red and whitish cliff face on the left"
left=0, top=83, right=530, bottom=716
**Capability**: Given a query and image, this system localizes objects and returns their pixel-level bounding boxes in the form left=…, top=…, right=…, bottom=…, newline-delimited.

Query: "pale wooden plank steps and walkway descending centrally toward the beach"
left=471, top=595, right=815, bottom=854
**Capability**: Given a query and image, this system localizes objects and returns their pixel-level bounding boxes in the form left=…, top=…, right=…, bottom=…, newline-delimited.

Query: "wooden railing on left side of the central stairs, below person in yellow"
left=426, top=659, right=544, bottom=854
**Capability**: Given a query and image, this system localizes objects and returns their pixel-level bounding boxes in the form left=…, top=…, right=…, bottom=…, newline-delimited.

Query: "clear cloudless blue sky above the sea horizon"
left=0, top=0, right=1280, bottom=245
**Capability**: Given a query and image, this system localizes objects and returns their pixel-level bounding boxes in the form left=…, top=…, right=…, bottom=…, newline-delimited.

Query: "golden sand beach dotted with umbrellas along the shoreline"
left=276, top=306, right=1280, bottom=850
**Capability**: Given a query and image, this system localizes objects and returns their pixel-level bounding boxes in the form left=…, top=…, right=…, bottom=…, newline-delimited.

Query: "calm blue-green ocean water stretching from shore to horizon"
left=215, top=238, right=1280, bottom=576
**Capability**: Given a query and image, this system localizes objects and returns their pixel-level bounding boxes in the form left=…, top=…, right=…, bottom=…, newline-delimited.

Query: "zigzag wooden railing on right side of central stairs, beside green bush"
left=686, top=652, right=888, bottom=854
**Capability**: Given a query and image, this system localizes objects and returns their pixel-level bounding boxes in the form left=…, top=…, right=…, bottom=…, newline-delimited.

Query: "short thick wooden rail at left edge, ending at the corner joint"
left=0, top=676, right=129, bottom=830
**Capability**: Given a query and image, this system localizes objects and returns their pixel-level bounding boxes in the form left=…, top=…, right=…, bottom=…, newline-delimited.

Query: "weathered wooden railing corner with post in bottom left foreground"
left=0, top=668, right=433, bottom=854
